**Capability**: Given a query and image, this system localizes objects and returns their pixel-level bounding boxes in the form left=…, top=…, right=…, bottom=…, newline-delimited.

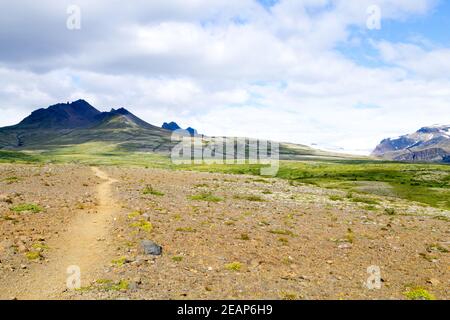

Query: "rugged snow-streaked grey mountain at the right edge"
left=372, top=125, right=450, bottom=163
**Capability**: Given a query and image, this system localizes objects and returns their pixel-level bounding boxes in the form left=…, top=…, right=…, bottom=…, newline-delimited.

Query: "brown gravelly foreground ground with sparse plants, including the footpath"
left=0, top=164, right=450, bottom=299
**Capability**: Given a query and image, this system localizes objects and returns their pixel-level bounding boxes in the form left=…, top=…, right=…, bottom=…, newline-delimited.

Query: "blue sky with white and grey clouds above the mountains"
left=0, top=0, right=450, bottom=154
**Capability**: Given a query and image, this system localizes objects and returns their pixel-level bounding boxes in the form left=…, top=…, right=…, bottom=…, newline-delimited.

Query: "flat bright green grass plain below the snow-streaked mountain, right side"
left=184, top=160, right=450, bottom=210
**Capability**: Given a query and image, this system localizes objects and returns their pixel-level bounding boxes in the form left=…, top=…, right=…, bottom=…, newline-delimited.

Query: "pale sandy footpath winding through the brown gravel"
left=1, top=167, right=119, bottom=300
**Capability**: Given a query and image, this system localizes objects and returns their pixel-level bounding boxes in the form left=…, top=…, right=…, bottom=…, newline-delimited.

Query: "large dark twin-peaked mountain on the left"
left=0, top=99, right=170, bottom=150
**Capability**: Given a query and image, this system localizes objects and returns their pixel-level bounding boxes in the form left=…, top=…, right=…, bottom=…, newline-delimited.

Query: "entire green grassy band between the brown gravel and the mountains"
left=0, top=142, right=450, bottom=210
